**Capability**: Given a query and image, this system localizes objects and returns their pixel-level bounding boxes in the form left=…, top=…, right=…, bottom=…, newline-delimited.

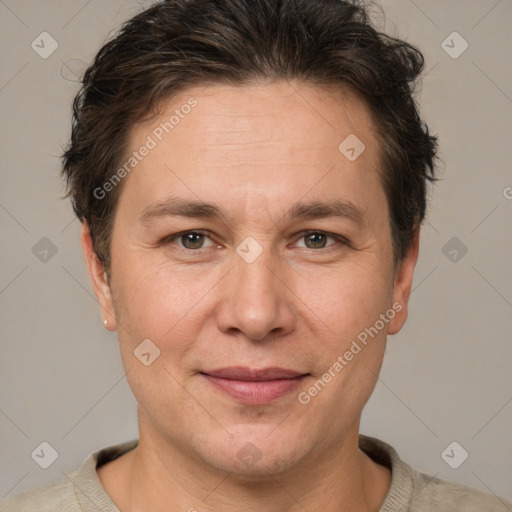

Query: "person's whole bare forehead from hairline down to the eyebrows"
left=116, top=82, right=386, bottom=228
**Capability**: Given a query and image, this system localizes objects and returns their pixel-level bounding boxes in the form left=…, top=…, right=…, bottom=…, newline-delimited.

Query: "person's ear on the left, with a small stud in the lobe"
left=81, top=222, right=116, bottom=331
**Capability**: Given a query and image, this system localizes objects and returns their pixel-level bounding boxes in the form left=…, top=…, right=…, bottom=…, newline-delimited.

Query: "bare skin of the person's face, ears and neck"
left=82, top=82, right=419, bottom=512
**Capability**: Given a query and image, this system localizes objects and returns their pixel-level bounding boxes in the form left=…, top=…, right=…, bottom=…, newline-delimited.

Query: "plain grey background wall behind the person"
left=0, top=0, right=512, bottom=499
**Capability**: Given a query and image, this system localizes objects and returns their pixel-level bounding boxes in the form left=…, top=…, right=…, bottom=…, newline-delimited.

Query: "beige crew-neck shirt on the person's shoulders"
left=0, top=434, right=512, bottom=512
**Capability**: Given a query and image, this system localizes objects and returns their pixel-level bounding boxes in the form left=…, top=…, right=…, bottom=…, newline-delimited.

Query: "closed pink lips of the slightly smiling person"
left=201, top=366, right=310, bottom=405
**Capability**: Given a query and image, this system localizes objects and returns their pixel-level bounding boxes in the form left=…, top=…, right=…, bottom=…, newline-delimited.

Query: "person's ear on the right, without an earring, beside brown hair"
left=388, top=226, right=420, bottom=334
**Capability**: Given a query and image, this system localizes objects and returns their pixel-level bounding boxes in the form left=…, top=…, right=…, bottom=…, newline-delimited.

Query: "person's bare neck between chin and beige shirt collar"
left=102, top=414, right=391, bottom=512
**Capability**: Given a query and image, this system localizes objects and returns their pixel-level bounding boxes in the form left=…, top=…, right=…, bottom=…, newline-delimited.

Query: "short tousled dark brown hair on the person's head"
left=62, top=0, right=437, bottom=276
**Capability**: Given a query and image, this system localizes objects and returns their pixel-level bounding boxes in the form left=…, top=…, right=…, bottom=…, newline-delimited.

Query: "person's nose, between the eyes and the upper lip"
left=217, top=242, right=296, bottom=341
